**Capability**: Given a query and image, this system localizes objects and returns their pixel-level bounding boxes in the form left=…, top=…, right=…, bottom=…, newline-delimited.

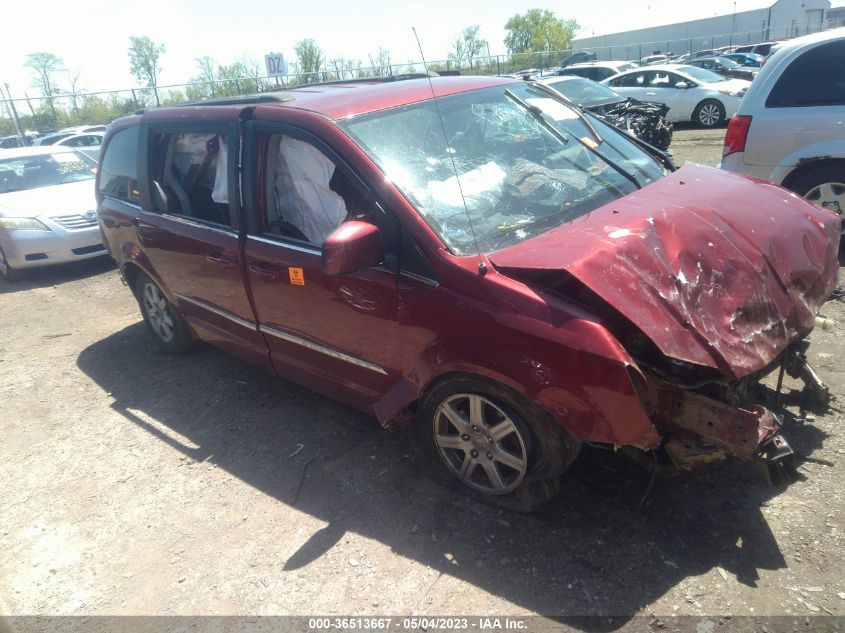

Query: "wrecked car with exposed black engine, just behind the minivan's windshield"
left=539, top=75, right=672, bottom=150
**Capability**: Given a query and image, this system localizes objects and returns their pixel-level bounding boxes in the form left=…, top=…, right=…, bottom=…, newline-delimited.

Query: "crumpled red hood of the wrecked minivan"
left=490, top=164, right=840, bottom=378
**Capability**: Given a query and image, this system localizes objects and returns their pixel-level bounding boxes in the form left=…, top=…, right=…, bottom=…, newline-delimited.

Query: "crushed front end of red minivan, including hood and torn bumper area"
left=491, top=165, right=840, bottom=478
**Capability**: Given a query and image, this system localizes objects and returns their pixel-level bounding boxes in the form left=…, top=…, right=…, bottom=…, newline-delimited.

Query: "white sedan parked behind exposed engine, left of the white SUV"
left=602, top=64, right=751, bottom=127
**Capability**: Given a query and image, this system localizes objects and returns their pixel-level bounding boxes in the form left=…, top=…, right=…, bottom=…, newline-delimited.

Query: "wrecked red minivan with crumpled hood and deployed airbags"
left=97, top=77, right=839, bottom=510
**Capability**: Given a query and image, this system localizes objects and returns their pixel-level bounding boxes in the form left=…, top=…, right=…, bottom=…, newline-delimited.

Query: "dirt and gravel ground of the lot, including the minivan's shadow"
left=0, top=129, right=845, bottom=631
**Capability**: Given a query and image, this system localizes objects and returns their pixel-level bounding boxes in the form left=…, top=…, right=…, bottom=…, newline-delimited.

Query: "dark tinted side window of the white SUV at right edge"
left=766, top=40, right=845, bottom=108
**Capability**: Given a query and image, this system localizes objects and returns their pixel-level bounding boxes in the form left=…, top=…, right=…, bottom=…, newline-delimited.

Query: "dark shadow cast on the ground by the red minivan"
left=78, top=323, right=823, bottom=629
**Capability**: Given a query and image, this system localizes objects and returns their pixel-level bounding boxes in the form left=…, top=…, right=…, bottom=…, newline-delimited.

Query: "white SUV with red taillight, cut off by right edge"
left=721, top=28, right=845, bottom=213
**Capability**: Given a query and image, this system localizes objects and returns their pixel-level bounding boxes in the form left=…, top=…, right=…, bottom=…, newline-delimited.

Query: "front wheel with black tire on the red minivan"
left=411, top=376, right=581, bottom=513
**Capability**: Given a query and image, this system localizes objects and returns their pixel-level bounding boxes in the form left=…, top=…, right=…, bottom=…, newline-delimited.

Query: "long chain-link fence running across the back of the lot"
left=0, top=23, right=839, bottom=144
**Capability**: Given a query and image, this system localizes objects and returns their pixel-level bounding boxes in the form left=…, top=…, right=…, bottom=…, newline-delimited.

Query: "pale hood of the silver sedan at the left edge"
left=0, top=178, right=97, bottom=218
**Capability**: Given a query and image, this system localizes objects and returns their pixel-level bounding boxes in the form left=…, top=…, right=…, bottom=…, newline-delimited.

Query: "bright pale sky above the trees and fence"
left=0, top=0, right=784, bottom=97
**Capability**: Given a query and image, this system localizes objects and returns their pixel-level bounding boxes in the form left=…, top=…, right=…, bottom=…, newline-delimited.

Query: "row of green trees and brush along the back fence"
left=0, top=9, right=578, bottom=135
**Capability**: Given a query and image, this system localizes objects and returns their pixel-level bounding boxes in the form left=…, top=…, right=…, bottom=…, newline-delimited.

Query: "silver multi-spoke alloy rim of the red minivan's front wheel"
left=433, top=393, right=528, bottom=495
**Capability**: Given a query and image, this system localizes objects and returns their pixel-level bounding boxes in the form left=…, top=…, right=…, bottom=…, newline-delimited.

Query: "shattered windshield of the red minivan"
left=341, top=83, right=665, bottom=255
